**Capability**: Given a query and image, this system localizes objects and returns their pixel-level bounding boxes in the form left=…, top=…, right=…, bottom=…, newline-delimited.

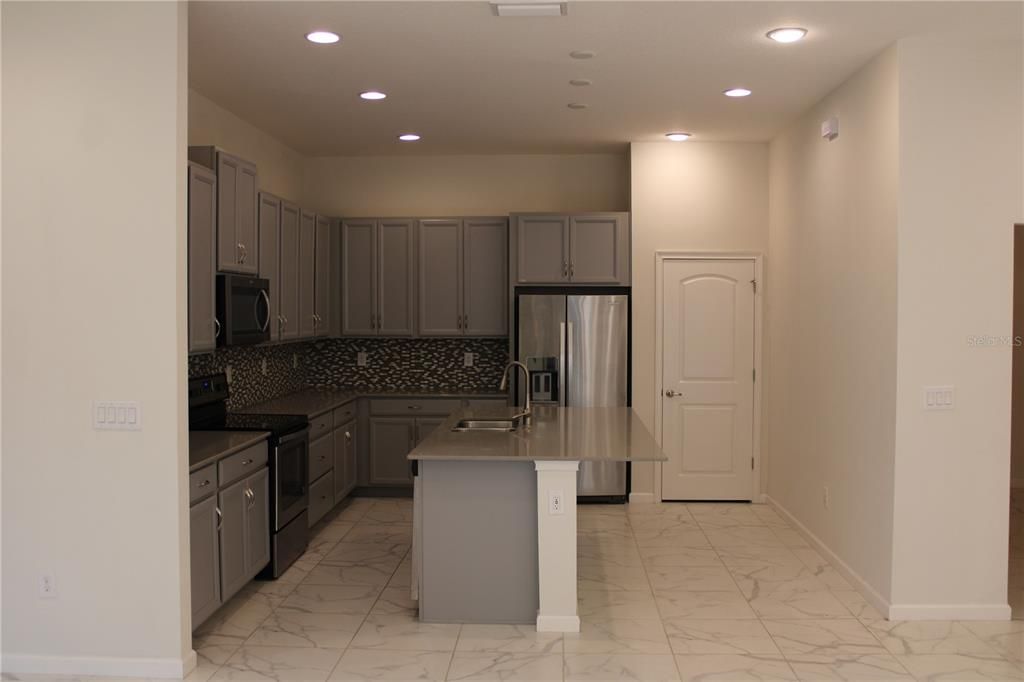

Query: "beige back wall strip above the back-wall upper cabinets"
left=303, top=154, right=630, bottom=216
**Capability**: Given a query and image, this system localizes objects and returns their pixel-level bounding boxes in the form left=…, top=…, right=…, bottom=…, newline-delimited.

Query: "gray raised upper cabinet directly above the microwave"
left=188, top=146, right=259, bottom=274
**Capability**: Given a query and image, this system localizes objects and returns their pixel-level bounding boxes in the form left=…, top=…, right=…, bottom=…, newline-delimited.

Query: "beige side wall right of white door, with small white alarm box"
left=764, top=48, right=899, bottom=602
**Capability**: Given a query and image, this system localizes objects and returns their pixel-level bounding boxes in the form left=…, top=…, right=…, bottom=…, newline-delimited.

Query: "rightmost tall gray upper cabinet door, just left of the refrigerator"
left=463, top=218, right=509, bottom=336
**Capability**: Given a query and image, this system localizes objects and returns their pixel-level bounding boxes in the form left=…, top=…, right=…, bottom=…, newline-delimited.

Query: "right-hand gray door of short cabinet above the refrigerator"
left=569, top=215, right=629, bottom=284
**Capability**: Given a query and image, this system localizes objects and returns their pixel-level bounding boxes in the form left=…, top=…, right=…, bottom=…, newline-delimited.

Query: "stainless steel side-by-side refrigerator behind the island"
left=516, top=292, right=630, bottom=499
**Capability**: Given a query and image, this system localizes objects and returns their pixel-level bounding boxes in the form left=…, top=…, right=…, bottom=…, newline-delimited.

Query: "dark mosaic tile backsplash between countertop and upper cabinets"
left=188, top=339, right=508, bottom=409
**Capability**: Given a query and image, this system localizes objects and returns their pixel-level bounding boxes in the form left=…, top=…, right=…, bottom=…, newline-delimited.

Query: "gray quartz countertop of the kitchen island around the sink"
left=409, top=407, right=668, bottom=462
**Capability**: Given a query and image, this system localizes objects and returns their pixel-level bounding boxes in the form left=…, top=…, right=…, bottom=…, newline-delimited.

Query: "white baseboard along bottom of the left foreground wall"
left=0, top=650, right=197, bottom=680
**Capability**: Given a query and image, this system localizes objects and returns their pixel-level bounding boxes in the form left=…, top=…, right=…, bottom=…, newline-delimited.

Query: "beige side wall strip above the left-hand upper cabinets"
left=188, top=90, right=304, bottom=202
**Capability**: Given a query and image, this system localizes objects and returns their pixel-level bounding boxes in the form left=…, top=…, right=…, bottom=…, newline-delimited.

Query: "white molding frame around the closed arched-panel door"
left=653, top=250, right=765, bottom=502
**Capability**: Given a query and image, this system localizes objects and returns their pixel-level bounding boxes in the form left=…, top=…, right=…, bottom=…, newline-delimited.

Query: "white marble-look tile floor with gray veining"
left=5, top=495, right=1024, bottom=682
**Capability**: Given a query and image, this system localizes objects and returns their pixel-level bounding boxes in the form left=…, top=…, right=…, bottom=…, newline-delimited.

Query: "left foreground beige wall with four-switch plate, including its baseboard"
left=0, top=2, right=190, bottom=677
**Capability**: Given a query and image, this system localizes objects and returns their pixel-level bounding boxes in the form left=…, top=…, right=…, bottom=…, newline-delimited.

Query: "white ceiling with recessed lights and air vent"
left=189, top=1, right=1022, bottom=156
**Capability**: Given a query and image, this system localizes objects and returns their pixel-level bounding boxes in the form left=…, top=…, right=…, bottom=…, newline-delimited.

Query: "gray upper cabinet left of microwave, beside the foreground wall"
left=188, top=163, right=219, bottom=352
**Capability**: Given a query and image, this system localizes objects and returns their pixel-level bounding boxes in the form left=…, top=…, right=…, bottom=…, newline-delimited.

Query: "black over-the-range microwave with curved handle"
left=217, top=273, right=270, bottom=346
